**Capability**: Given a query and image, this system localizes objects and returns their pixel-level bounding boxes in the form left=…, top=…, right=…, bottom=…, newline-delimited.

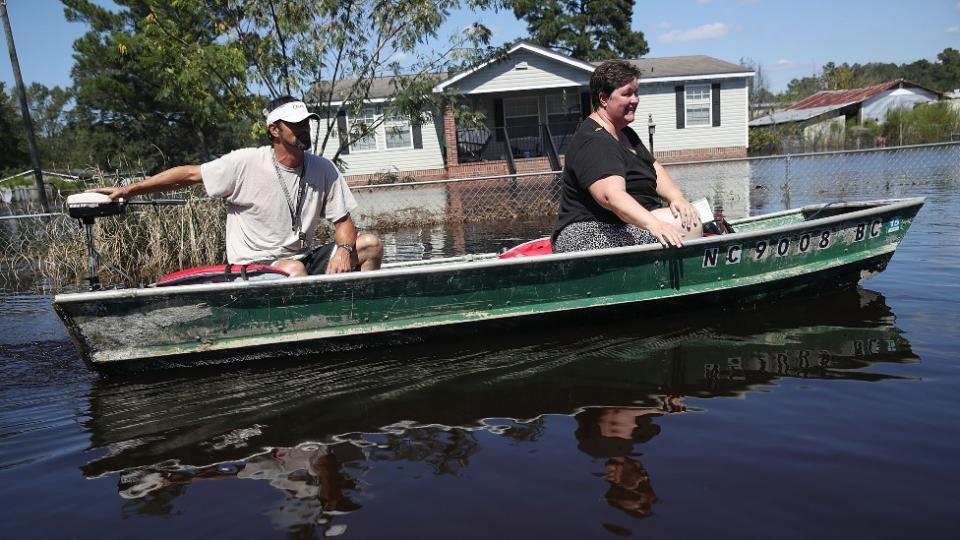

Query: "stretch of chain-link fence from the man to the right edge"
left=353, top=142, right=960, bottom=226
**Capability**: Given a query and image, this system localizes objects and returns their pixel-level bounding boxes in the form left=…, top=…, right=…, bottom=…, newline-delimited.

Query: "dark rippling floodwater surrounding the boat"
left=0, top=149, right=960, bottom=539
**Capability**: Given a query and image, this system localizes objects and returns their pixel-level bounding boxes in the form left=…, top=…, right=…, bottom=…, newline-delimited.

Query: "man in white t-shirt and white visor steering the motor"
left=91, top=96, right=383, bottom=277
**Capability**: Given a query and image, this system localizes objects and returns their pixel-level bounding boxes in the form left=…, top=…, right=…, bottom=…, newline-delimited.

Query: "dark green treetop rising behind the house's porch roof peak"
left=513, top=0, right=650, bottom=60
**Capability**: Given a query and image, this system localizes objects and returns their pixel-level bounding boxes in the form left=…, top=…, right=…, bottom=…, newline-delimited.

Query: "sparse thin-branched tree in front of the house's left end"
left=236, top=0, right=502, bottom=163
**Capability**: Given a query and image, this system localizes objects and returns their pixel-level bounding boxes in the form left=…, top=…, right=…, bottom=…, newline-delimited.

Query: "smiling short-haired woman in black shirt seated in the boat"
left=553, top=60, right=702, bottom=253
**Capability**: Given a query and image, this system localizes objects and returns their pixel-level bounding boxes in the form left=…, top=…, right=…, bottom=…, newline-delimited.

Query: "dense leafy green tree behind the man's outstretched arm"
left=62, top=0, right=258, bottom=170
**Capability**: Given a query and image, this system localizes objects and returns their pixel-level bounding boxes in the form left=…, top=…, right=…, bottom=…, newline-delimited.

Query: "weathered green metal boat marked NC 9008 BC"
left=54, top=198, right=924, bottom=368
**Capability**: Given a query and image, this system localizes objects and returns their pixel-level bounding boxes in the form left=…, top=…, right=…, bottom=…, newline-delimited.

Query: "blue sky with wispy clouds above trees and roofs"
left=0, top=0, right=960, bottom=92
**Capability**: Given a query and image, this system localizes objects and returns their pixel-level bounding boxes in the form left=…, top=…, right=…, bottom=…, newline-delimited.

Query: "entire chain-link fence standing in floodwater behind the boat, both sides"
left=0, top=143, right=960, bottom=289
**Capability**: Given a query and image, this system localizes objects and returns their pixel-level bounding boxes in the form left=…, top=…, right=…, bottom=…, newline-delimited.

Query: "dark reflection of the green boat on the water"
left=83, top=290, right=916, bottom=506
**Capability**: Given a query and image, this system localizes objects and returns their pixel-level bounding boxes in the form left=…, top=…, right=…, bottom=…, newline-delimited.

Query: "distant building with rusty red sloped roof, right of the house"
left=749, top=79, right=943, bottom=149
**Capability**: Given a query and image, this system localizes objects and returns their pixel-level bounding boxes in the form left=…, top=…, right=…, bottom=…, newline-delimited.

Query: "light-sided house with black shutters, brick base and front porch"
left=316, top=42, right=754, bottom=182
